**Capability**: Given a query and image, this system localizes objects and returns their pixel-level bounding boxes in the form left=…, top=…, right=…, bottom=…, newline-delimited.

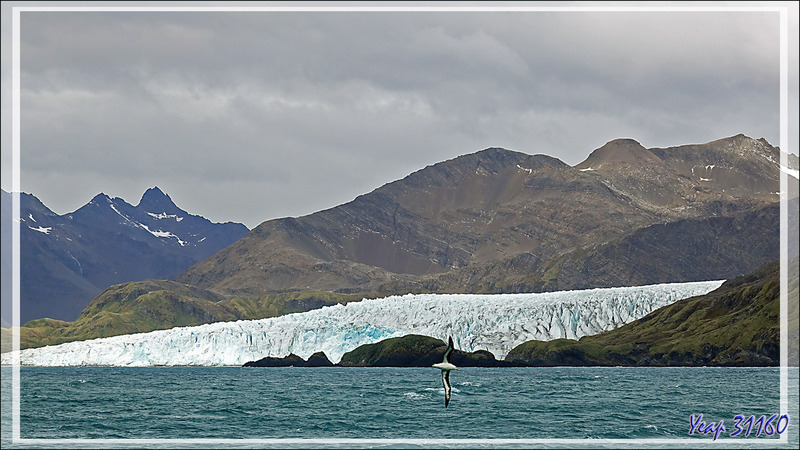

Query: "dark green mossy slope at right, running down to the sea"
left=506, top=258, right=798, bottom=366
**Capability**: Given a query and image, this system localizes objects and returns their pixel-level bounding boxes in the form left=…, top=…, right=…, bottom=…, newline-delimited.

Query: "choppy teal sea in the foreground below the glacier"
left=2, top=367, right=800, bottom=448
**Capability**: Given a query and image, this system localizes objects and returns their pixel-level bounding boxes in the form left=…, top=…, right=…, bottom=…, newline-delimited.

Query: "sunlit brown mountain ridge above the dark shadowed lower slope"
left=176, top=135, right=796, bottom=296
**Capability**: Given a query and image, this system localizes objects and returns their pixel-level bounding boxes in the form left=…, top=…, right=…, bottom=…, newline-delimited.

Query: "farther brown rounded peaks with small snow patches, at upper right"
left=575, top=134, right=797, bottom=214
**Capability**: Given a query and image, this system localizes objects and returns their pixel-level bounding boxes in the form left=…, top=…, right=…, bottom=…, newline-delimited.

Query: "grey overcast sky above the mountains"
left=2, top=2, right=798, bottom=228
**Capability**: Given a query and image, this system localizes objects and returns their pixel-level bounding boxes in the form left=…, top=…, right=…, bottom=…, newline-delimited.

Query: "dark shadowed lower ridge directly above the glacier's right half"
left=418, top=198, right=798, bottom=292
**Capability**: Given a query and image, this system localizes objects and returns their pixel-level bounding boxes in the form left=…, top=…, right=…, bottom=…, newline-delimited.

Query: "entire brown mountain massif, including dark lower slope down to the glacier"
left=176, top=135, right=797, bottom=297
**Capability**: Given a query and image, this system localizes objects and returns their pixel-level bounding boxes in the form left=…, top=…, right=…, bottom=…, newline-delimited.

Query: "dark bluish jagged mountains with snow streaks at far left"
left=2, top=187, right=248, bottom=323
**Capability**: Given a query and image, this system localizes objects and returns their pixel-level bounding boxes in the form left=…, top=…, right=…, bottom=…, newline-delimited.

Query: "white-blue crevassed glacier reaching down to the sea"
left=2, top=281, right=723, bottom=366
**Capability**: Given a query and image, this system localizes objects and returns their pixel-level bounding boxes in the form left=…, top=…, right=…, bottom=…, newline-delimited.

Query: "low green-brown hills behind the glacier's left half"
left=2, top=280, right=362, bottom=351
